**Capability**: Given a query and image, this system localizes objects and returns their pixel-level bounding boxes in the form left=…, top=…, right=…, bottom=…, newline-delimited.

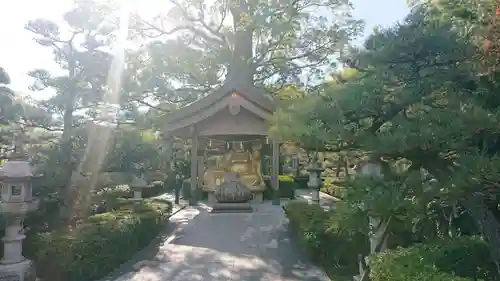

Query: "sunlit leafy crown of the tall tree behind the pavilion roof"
left=128, top=0, right=361, bottom=100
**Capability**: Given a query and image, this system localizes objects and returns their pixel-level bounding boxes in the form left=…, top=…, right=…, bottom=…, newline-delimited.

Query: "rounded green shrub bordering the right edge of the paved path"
left=285, top=201, right=369, bottom=271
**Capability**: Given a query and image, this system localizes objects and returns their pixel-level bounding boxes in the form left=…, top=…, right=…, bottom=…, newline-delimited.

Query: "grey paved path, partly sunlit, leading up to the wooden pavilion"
left=115, top=203, right=330, bottom=281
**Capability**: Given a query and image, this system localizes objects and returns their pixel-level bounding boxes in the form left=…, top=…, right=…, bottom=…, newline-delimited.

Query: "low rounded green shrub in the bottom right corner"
left=370, top=237, right=496, bottom=281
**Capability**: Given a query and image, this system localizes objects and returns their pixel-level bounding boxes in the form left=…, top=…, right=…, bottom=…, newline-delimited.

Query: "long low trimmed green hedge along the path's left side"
left=25, top=199, right=172, bottom=281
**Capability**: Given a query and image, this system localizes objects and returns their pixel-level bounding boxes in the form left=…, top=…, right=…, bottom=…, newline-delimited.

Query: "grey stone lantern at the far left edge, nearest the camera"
left=0, top=148, right=39, bottom=281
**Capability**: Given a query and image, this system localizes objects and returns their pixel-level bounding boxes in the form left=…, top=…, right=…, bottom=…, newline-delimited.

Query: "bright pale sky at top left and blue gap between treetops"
left=0, top=0, right=409, bottom=98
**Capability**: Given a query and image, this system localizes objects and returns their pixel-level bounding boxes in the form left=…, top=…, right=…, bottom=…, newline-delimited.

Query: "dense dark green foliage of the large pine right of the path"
left=273, top=0, right=500, bottom=274
